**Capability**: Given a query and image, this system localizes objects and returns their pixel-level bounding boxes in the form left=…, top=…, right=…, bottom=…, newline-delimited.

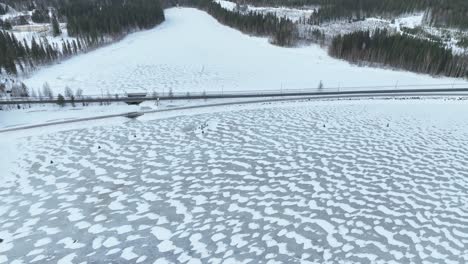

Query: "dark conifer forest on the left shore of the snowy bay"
left=0, top=0, right=164, bottom=75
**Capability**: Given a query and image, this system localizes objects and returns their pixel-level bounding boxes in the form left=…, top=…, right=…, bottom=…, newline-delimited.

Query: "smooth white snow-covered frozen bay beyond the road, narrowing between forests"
left=21, top=8, right=464, bottom=95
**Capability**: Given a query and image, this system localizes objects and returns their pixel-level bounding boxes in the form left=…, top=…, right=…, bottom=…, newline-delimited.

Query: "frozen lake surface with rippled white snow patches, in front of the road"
left=0, top=100, right=468, bottom=263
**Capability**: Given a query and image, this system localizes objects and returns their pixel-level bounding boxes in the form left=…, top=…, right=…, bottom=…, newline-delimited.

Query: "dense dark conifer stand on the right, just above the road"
left=328, top=29, right=468, bottom=78
